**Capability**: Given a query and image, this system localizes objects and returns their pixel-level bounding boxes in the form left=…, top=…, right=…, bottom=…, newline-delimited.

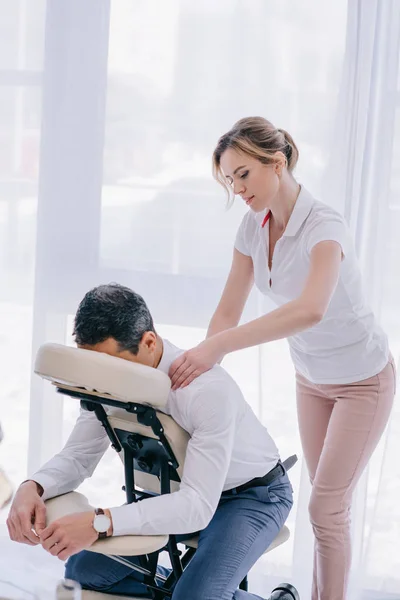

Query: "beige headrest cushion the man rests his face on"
left=35, top=344, right=171, bottom=409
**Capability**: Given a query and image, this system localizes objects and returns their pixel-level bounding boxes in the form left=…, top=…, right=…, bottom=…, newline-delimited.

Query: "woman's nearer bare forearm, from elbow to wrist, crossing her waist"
left=214, top=299, right=322, bottom=354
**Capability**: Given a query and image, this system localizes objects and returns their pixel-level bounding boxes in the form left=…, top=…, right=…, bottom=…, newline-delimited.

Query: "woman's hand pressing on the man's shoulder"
left=169, top=337, right=224, bottom=390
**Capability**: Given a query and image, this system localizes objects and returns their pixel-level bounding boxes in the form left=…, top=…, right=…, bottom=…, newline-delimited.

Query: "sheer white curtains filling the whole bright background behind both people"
left=0, top=0, right=400, bottom=598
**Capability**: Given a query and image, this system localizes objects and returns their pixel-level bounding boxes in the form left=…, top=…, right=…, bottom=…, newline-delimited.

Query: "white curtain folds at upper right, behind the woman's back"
left=326, top=0, right=400, bottom=312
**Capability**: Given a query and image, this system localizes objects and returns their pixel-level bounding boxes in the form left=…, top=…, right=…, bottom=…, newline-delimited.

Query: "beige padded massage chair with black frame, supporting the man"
left=35, top=344, right=295, bottom=600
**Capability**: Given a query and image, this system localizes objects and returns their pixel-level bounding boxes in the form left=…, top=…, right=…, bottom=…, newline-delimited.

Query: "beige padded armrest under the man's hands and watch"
left=46, top=492, right=169, bottom=556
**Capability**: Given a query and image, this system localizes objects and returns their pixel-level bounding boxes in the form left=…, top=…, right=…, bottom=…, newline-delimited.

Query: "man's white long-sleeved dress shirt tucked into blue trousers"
left=31, top=340, right=279, bottom=535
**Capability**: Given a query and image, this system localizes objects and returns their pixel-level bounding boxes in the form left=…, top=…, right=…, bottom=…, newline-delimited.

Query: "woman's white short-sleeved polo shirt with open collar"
left=235, top=187, right=389, bottom=383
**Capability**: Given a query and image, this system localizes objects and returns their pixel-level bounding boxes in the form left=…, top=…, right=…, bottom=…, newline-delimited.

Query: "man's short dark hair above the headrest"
left=73, top=283, right=155, bottom=355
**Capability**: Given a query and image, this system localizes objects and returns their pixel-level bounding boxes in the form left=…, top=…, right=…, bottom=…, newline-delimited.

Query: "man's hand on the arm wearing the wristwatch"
left=40, top=511, right=98, bottom=560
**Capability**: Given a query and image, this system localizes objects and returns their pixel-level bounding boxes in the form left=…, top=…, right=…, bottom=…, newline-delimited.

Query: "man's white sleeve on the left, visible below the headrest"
left=29, top=410, right=110, bottom=500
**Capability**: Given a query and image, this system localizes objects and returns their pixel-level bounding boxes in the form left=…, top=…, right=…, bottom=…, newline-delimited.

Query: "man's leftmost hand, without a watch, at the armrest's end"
left=7, top=481, right=46, bottom=546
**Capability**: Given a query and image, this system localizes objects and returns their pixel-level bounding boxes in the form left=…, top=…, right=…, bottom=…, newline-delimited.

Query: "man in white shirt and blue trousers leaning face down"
left=7, top=284, right=292, bottom=600
